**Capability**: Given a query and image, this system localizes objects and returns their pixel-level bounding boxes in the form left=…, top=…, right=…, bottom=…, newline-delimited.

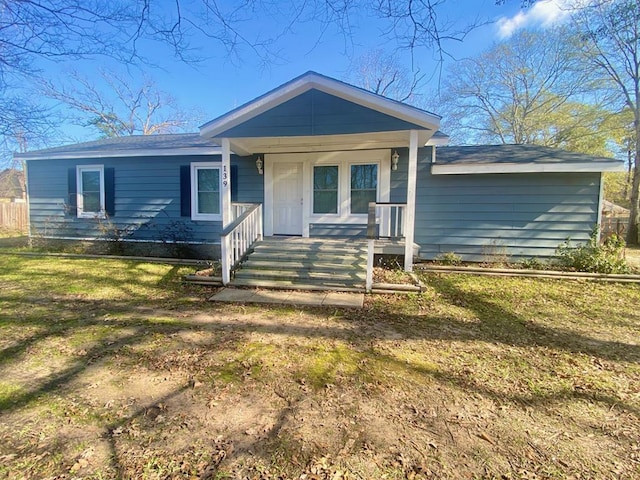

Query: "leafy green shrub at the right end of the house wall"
left=556, top=229, right=629, bottom=273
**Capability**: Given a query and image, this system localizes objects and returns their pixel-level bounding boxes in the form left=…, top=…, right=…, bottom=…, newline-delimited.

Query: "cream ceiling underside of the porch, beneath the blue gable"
left=221, top=130, right=433, bottom=156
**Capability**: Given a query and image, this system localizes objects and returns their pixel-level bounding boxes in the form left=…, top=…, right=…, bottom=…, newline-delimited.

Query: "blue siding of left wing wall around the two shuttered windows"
left=27, top=155, right=264, bottom=243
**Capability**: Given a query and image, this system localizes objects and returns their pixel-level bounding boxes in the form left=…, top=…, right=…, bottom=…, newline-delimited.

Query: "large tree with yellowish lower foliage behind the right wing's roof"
left=439, top=29, right=610, bottom=153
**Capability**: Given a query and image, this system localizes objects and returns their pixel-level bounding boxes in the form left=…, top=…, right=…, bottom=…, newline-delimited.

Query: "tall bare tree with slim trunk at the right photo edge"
left=573, top=0, right=640, bottom=245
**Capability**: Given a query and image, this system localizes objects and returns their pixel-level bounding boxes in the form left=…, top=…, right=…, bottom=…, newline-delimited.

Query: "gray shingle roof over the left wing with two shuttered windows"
left=15, top=133, right=220, bottom=160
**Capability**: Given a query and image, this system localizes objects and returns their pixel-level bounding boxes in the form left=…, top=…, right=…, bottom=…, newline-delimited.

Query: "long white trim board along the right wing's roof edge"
left=431, top=162, right=624, bottom=175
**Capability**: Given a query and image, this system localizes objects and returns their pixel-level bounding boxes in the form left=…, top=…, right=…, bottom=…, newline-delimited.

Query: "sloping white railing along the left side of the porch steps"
left=220, top=203, right=262, bottom=285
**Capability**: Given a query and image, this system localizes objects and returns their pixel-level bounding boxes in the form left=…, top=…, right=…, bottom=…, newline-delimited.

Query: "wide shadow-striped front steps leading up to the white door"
left=231, top=237, right=367, bottom=292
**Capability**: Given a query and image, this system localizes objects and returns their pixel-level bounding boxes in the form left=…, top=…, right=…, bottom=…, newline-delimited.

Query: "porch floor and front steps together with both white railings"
left=221, top=202, right=419, bottom=292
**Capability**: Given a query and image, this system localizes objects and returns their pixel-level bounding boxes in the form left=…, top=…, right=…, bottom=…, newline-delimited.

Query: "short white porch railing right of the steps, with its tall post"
left=365, top=202, right=407, bottom=292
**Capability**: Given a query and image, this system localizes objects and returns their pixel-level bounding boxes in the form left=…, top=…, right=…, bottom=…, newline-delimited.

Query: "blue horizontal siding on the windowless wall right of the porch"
left=412, top=149, right=600, bottom=261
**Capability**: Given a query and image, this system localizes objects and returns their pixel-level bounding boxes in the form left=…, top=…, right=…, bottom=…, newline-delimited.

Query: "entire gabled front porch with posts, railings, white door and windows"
left=200, top=72, right=442, bottom=291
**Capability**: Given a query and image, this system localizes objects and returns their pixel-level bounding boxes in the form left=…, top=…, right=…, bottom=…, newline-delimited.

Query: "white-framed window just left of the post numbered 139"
left=191, top=163, right=222, bottom=220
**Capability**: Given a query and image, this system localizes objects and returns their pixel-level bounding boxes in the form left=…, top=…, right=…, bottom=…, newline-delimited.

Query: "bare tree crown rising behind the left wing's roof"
left=42, top=71, right=202, bottom=137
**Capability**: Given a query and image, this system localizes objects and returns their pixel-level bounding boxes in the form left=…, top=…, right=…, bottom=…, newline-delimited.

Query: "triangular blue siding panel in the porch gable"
left=219, top=89, right=424, bottom=138
